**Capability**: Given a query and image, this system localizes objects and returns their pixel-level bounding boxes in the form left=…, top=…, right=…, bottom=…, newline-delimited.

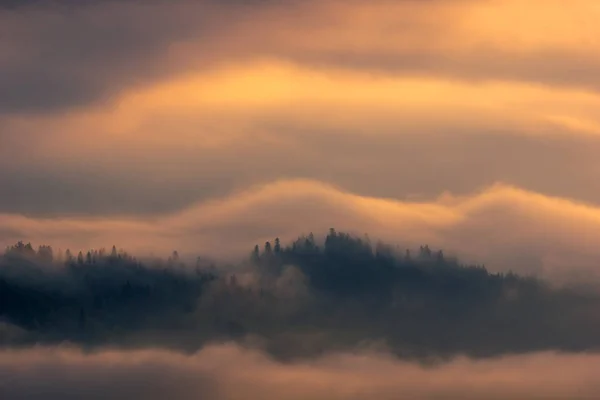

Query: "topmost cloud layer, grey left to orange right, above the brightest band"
left=0, top=0, right=600, bottom=112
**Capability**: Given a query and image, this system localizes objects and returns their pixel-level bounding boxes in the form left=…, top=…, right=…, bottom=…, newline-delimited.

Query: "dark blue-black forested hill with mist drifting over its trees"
left=0, top=229, right=600, bottom=358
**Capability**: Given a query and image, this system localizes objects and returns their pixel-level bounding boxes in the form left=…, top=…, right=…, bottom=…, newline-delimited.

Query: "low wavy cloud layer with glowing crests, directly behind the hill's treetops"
left=0, top=180, right=600, bottom=280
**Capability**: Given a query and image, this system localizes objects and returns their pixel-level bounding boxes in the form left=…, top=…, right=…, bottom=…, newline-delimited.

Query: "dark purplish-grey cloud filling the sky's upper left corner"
left=0, top=1, right=251, bottom=114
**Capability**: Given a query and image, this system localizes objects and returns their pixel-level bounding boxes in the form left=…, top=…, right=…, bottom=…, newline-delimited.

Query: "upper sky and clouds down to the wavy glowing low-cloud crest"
left=0, top=0, right=600, bottom=225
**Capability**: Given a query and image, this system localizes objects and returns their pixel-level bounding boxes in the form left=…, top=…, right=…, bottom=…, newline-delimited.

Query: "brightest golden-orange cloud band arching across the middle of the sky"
left=6, top=61, right=600, bottom=161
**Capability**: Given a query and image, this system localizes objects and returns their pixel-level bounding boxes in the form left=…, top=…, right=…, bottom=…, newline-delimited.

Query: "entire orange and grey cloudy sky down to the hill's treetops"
left=0, top=0, right=600, bottom=275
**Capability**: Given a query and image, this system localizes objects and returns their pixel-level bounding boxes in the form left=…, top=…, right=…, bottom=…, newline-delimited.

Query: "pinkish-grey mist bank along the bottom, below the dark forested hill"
left=0, top=344, right=600, bottom=400
